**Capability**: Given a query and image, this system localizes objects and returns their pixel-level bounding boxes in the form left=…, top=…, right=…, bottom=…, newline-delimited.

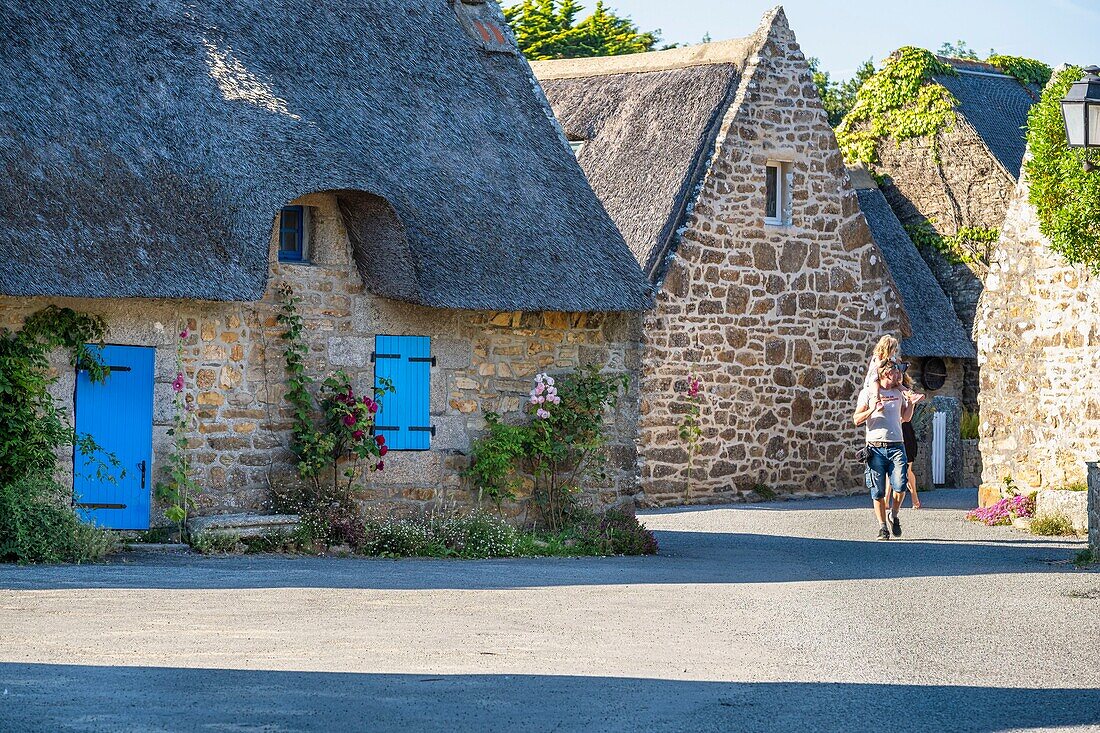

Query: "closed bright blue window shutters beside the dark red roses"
left=374, top=336, right=436, bottom=450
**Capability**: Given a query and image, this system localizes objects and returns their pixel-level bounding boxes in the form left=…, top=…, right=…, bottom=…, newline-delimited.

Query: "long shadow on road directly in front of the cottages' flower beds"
left=0, top=521, right=1074, bottom=590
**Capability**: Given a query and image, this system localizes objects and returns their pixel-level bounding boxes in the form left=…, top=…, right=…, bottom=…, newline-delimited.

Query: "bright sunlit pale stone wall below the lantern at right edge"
left=977, top=173, right=1100, bottom=502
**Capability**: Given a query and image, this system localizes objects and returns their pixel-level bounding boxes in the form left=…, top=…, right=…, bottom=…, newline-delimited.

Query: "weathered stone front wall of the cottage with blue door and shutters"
left=0, top=194, right=640, bottom=514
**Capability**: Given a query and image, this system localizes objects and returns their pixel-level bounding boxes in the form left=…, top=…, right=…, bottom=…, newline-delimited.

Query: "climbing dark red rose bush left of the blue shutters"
left=275, top=285, right=394, bottom=522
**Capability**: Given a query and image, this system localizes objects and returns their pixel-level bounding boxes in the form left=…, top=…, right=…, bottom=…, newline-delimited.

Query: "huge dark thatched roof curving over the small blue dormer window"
left=0, top=0, right=650, bottom=310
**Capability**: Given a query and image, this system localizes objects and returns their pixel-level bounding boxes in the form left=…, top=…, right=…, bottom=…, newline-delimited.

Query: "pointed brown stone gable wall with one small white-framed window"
left=641, top=22, right=903, bottom=504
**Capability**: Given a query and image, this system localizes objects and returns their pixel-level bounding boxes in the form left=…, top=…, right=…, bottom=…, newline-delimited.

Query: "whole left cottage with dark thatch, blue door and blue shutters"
left=0, top=0, right=651, bottom=528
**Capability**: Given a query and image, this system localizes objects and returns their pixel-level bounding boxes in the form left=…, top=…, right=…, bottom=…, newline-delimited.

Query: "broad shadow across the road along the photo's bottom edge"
left=0, top=664, right=1100, bottom=733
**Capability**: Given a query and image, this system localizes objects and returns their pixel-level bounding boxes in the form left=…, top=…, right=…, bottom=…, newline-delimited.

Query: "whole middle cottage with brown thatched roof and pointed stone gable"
left=532, top=9, right=909, bottom=504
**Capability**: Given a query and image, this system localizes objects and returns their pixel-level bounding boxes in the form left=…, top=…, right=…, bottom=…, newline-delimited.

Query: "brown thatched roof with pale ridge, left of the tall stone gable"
left=531, top=31, right=765, bottom=280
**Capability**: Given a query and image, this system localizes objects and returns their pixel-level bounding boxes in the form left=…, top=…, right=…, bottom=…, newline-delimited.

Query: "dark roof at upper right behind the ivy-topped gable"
left=936, top=56, right=1042, bottom=178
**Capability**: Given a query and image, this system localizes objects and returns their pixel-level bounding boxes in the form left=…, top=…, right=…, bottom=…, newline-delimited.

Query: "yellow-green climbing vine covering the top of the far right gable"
left=836, top=46, right=958, bottom=165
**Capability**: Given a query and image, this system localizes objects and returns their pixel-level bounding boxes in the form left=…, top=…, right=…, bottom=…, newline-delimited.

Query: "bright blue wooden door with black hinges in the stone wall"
left=73, top=346, right=154, bottom=529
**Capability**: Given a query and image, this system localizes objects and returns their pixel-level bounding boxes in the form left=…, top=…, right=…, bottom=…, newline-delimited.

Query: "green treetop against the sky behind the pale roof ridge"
left=504, top=0, right=660, bottom=61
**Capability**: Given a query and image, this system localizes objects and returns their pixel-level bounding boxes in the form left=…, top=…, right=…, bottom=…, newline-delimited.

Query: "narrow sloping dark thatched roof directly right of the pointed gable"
left=850, top=168, right=977, bottom=359
